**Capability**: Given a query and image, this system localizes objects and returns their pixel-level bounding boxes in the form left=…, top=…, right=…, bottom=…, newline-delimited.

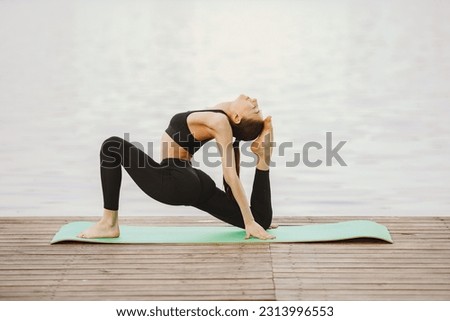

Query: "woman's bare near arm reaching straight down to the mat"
left=213, top=117, right=274, bottom=240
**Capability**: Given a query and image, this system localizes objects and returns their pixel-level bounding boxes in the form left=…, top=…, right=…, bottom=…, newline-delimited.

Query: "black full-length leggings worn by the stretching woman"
left=100, top=136, right=272, bottom=229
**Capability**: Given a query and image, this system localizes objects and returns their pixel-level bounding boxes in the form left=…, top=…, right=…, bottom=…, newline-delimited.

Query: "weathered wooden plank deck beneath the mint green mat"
left=0, top=216, right=450, bottom=300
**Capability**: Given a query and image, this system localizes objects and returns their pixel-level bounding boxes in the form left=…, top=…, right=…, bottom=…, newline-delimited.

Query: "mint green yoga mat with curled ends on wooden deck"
left=51, top=220, right=393, bottom=244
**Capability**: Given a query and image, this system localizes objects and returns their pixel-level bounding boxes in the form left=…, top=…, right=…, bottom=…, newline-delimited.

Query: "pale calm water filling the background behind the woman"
left=0, top=0, right=450, bottom=216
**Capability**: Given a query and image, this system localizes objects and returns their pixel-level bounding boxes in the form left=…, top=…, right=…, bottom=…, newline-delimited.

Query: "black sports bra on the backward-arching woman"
left=166, top=109, right=226, bottom=155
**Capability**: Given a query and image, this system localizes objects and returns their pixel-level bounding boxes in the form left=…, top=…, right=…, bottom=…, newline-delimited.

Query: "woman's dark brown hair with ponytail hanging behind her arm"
left=223, top=119, right=264, bottom=200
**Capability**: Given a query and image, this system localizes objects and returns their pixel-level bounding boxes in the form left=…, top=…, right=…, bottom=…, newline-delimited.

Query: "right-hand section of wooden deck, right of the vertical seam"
left=271, top=218, right=450, bottom=300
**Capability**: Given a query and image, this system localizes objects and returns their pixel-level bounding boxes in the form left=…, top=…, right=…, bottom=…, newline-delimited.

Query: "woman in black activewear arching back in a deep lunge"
left=78, top=95, right=274, bottom=240
